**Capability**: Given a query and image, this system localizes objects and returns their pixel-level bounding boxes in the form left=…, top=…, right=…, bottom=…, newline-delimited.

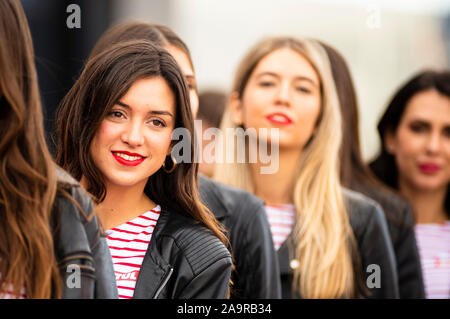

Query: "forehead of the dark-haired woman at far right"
left=403, top=90, right=450, bottom=125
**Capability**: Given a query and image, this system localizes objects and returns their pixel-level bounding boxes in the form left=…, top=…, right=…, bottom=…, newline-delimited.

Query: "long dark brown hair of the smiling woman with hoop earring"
left=57, top=40, right=227, bottom=248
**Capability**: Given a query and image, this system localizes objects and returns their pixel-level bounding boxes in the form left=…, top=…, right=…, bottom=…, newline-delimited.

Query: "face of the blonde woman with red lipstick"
left=231, top=48, right=321, bottom=150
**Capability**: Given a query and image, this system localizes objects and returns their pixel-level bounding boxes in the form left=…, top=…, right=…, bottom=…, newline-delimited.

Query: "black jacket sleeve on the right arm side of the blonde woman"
left=359, top=204, right=399, bottom=299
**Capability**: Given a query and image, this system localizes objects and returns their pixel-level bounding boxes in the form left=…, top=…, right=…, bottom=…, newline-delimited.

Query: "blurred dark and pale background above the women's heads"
left=22, top=0, right=450, bottom=160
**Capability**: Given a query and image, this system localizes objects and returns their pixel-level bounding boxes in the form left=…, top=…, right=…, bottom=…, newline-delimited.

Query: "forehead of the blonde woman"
left=253, top=48, right=319, bottom=83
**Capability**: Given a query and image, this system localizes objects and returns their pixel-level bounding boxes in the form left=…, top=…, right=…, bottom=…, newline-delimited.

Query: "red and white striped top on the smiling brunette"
left=107, top=205, right=161, bottom=299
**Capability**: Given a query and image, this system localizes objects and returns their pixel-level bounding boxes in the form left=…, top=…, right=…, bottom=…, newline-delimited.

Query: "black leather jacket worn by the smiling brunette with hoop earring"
left=133, top=207, right=232, bottom=299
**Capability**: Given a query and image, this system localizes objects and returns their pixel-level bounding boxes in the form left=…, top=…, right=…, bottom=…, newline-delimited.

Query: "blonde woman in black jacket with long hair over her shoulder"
left=214, top=37, right=398, bottom=298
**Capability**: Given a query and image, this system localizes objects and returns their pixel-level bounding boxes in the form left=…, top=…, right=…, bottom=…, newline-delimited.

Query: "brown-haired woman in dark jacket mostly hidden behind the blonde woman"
left=321, top=43, right=425, bottom=298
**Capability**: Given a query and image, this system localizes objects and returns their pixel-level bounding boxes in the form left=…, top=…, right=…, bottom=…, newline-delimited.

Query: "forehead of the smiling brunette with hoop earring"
left=120, top=76, right=175, bottom=114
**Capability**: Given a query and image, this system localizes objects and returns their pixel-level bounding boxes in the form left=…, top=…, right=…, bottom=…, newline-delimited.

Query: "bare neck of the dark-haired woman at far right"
left=399, top=180, right=448, bottom=224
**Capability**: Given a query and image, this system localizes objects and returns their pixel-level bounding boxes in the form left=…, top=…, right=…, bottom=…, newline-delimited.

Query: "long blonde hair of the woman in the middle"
left=214, top=37, right=357, bottom=298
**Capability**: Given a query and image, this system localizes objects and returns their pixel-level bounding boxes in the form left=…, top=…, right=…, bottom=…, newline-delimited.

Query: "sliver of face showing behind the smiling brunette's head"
left=165, top=45, right=199, bottom=118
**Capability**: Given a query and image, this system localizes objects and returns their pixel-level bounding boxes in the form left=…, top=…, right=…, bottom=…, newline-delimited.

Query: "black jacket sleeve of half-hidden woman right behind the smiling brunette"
left=233, top=205, right=281, bottom=299
